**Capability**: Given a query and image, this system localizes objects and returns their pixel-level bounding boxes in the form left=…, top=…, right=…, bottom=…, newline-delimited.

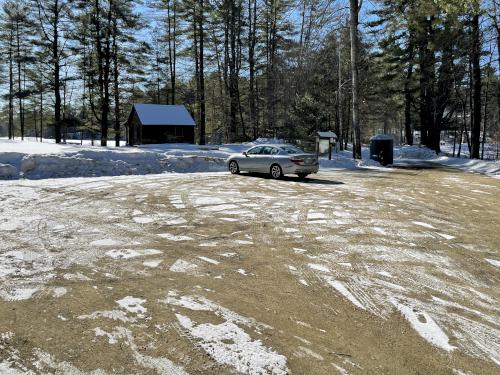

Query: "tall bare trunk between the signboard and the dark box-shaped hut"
left=349, top=0, right=361, bottom=159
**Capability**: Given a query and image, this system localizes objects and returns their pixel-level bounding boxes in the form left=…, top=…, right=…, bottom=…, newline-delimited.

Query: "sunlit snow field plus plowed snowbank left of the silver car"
left=0, top=140, right=228, bottom=179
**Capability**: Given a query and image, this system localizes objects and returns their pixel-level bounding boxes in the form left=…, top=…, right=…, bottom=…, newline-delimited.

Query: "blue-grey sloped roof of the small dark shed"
left=134, top=104, right=196, bottom=126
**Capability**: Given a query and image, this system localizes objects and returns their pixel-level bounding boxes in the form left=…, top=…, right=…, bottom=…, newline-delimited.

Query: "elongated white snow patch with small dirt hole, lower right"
left=391, top=299, right=456, bottom=352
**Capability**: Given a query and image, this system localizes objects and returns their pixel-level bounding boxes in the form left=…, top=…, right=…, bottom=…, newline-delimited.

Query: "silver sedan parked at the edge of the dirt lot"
left=227, top=144, right=319, bottom=179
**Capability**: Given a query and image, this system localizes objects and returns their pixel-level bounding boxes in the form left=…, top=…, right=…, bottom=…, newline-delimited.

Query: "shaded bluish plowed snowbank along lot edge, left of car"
left=0, top=150, right=226, bottom=180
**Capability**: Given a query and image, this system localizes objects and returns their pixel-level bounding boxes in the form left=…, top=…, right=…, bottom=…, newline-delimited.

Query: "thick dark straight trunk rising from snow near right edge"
left=470, top=14, right=481, bottom=159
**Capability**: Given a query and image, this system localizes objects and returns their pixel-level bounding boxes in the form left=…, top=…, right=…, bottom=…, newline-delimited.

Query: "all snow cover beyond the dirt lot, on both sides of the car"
left=0, top=139, right=500, bottom=180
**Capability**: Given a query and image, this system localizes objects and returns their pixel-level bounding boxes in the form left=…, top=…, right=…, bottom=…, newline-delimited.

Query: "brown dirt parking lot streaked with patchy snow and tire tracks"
left=0, top=169, right=500, bottom=374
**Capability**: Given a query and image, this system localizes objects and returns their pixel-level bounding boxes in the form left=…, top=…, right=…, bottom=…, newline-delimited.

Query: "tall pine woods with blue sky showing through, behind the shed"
left=0, top=0, right=500, bottom=158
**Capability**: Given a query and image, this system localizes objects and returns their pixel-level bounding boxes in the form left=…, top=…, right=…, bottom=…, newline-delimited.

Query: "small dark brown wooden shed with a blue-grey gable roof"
left=126, top=104, right=196, bottom=146
